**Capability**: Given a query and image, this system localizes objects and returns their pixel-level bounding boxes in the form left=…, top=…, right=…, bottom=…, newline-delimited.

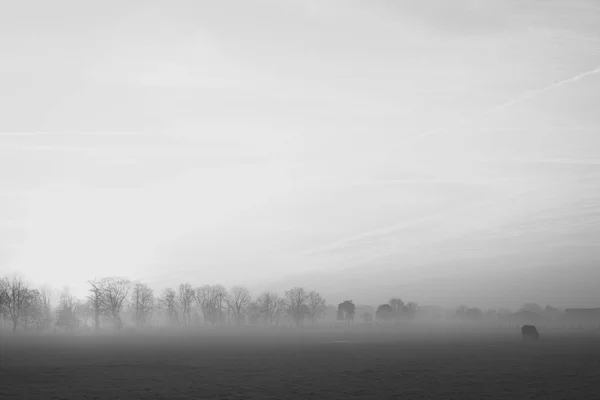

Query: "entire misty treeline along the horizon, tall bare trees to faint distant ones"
left=0, top=276, right=592, bottom=332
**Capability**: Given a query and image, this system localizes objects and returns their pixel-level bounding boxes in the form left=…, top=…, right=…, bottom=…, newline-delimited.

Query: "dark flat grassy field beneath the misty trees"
left=0, top=329, right=600, bottom=399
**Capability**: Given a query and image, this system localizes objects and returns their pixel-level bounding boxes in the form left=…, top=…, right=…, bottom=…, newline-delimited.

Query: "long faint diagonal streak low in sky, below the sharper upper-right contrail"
left=296, top=173, right=600, bottom=257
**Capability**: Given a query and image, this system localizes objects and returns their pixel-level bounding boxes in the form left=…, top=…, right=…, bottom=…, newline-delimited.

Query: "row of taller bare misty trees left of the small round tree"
left=0, top=276, right=327, bottom=331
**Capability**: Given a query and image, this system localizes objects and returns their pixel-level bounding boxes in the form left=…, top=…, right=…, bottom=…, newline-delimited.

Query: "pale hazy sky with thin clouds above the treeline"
left=0, top=0, right=600, bottom=306
